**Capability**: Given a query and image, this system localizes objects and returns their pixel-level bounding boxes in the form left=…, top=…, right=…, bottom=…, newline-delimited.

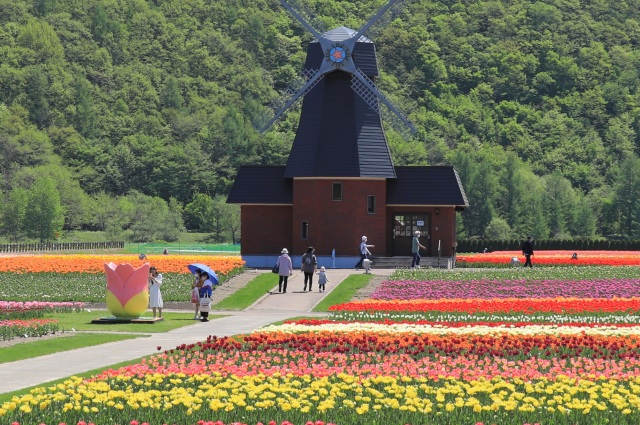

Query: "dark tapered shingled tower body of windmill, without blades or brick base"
left=284, top=71, right=395, bottom=178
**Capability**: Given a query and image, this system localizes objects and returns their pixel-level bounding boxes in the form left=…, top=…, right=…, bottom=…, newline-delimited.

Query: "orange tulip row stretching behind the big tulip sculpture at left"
left=0, top=254, right=244, bottom=275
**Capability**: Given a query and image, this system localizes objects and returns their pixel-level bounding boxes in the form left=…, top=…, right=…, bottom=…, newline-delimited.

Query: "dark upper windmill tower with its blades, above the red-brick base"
left=261, top=0, right=415, bottom=178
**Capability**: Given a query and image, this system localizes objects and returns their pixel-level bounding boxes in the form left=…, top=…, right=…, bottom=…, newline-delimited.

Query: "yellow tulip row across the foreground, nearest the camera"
left=0, top=373, right=640, bottom=424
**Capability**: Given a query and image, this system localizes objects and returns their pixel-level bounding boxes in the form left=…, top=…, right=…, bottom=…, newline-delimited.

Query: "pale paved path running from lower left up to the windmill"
left=0, top=269, right=393, bottom=394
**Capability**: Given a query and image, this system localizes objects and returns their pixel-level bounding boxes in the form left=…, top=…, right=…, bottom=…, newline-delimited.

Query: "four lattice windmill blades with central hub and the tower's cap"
left=257, top=0, right=416, bottom=136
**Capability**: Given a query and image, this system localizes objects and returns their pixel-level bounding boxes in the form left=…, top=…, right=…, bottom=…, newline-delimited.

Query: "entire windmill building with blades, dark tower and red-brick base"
left=227, top=0, right=468, bottom=267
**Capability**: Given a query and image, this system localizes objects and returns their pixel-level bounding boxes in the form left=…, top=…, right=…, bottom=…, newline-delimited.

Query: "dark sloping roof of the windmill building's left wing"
left=227, top=165, right=293, bottom=205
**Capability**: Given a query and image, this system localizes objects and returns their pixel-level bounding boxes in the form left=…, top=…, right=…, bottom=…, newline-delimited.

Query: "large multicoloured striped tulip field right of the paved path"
left=0, top=253, right=640, bottom=425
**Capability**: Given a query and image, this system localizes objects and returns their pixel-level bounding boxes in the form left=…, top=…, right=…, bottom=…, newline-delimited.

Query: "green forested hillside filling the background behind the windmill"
left=0, top=0, right=640, bottom=239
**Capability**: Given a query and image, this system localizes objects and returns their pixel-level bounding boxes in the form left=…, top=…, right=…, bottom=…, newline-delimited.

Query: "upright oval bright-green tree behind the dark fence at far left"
left=24, top=177, right=64, bottom=242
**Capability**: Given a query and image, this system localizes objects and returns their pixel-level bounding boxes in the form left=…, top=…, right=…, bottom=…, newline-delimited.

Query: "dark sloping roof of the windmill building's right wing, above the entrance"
left=387, top=167, right=469, bottom=207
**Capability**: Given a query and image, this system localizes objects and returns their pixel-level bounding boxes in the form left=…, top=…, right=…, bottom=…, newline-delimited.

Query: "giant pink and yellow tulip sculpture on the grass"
left=104, top=263, right=149, bottom=319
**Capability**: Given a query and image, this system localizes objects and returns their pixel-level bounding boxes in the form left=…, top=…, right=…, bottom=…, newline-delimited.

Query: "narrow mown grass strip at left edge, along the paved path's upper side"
left=0, top=333, right=141, bottom=363
